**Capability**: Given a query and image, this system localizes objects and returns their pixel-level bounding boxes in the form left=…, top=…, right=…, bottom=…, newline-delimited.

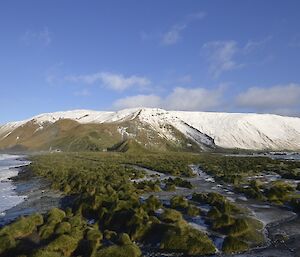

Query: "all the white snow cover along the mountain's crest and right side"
left=0, top=108, right=300, bottom=150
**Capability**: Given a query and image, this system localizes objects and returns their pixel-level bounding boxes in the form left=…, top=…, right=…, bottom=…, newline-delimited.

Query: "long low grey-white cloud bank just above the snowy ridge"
left=113, top=83, right=300, bottom=116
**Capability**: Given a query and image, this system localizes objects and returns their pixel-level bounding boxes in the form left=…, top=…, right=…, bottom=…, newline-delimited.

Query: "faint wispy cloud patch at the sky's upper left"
left=21, top=27, right=52, bottom=46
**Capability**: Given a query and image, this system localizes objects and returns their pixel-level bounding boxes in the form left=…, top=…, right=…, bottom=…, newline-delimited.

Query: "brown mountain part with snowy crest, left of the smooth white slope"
left=0, top=109, right=214, bottom=151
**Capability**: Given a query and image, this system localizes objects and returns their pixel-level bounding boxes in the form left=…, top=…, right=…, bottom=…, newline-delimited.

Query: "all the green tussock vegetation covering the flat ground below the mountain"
left=0, top=150, right=300, bottom=254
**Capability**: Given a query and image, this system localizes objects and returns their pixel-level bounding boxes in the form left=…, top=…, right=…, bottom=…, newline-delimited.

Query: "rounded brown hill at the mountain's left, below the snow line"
left=0, top=120, right=121, bottom=151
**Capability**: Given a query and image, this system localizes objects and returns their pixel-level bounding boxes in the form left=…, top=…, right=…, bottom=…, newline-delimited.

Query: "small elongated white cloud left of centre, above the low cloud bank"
left=65, top=72, right=151, bottom=91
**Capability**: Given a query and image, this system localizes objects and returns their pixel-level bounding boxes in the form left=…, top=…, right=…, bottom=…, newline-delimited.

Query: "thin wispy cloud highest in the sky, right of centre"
left=161, top=12, right=206, bottom=45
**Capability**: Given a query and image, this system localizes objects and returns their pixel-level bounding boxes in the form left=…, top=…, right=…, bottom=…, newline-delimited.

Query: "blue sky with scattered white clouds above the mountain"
left=0, top=0, right=300, bottom=123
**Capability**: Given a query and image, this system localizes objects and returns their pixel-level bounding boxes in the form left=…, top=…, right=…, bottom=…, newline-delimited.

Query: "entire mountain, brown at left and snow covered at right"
left=0, top=108, right=300, bottom=150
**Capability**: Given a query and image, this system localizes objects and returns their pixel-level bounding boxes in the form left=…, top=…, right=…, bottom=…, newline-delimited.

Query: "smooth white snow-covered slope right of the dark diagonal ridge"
left=171, top=112, right=300, bottom=150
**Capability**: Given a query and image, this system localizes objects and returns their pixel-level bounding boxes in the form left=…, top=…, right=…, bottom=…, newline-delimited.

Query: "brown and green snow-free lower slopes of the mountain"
left=0, top=119, right=206, bottom=151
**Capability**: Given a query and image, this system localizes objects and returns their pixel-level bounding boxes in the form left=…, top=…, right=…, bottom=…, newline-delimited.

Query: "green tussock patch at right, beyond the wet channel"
left=194, top=154, right=300, bottom=211
